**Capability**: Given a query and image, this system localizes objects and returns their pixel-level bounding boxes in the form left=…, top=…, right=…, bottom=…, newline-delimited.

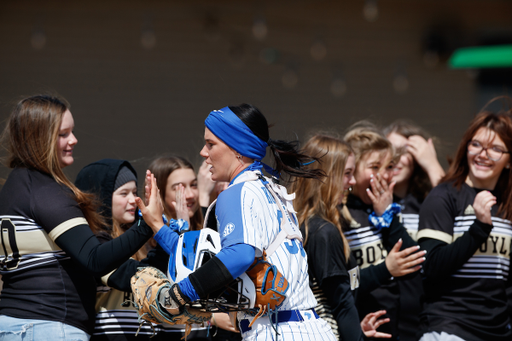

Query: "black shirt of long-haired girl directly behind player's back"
left=301, top=216, right=364, bottom=341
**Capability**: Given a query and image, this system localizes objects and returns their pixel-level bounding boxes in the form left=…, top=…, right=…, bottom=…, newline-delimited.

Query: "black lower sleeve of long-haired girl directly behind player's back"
left=320, top=276, right=365, bottom=341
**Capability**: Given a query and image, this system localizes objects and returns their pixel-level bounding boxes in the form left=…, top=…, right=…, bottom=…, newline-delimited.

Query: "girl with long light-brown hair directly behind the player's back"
left=292, top=134, right=391, bottom=341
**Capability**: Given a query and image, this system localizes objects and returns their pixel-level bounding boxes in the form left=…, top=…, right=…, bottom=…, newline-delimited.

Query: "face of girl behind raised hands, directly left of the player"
left=165, top=168, right=199, bottom=218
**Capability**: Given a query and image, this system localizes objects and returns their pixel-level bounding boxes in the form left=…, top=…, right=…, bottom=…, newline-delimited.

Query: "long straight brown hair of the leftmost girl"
left=2, top=95, right=104, bottom=232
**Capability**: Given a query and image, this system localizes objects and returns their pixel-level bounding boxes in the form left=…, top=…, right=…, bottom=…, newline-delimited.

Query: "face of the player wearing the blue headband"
left=199, top=128, right=240, bottom=181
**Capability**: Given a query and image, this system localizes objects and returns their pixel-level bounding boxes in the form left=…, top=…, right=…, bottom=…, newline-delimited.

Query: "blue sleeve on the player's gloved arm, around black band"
left=178, top=244, right=255, bottom=301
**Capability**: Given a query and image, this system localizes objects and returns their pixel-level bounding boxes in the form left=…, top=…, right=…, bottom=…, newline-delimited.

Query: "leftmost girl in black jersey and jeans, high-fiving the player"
left=0, top=95, right=163, bottom=340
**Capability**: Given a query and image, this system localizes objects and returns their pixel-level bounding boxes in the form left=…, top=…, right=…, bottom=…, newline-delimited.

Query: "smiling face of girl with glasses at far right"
left=466, top=127, right=510, bottom=190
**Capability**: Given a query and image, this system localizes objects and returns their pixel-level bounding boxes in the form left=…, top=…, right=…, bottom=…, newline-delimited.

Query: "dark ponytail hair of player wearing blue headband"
left=229, top=103, right=325, bottom=179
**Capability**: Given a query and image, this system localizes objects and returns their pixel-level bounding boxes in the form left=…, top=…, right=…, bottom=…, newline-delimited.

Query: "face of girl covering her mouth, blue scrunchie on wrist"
left=352, top=150, right=394, bottom=205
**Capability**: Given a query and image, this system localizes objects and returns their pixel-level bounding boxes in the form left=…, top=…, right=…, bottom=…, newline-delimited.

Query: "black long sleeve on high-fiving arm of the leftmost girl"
left=55, top=221, right=153, bottom=276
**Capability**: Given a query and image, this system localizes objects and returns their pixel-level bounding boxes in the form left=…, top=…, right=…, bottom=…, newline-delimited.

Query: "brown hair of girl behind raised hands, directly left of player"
left=148, top=155, right=203, bottom=230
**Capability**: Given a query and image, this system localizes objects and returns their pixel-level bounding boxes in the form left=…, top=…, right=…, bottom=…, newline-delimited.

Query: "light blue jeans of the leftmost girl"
left=0, top=315, right=91, bottom=341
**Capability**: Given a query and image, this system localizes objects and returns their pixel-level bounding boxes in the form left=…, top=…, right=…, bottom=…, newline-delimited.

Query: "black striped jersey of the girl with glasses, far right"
left=418, top=183, right=512, bottom=341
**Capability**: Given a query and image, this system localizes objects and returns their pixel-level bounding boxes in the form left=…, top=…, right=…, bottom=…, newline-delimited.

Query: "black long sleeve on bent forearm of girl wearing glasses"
left=419, top=220, right=492, bottom=279
